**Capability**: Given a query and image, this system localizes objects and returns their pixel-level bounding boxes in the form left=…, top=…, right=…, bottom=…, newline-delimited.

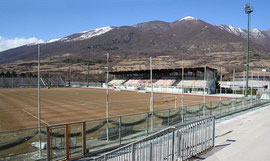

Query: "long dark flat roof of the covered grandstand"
left=110, top=66, right=217, bottom=75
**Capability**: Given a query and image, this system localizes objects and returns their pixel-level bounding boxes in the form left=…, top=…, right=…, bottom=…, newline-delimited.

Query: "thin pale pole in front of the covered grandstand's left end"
left=106, top=53, right=110, bottom=141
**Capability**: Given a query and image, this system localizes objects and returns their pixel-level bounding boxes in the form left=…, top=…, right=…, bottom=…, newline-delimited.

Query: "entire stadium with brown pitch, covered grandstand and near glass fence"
left=0, top=57, right=266, bottom=160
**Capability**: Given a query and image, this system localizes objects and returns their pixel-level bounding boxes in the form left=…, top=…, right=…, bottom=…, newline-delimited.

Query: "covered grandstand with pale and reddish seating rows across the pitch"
left=109, top=67, right=217, bottom=93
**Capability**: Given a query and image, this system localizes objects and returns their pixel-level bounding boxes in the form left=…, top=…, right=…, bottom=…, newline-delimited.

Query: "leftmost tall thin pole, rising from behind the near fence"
left=38, top=44, right=42, bottom=157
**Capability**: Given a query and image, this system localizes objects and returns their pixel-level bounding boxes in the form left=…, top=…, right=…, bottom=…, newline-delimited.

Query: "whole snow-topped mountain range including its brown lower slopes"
left=0, top=16, right=270, bottom=80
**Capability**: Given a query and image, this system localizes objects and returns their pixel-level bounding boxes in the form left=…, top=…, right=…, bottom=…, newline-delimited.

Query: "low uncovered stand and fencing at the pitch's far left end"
left=0, top=77, right=66, bottom=88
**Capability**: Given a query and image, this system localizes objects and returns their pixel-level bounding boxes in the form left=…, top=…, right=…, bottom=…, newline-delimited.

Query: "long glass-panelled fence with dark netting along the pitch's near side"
left=0, top=97, right=270, bottom=160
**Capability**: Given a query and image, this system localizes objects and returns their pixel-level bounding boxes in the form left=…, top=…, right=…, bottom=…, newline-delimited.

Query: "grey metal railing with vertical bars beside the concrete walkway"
left=93, top=116, right=215, bottom=161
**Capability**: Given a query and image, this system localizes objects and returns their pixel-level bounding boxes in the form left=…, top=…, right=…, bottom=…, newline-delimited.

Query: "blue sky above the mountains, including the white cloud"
left=0, top=0, right=270, bottom=51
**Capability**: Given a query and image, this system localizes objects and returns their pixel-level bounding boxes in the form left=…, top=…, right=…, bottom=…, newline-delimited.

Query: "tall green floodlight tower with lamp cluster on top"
left=245, top=3, right=253, bottom=97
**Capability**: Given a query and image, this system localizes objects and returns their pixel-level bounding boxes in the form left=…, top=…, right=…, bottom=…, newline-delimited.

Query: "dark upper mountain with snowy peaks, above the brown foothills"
left=0, top=16, right=270, bottom=64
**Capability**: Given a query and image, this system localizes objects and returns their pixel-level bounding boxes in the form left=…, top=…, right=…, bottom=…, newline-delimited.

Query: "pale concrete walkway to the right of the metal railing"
left=204, top=105, right=270, bottom=161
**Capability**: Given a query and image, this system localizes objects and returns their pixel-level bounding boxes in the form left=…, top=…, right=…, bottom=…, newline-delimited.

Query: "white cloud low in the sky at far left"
left=0, top=36, right=43, bottom=52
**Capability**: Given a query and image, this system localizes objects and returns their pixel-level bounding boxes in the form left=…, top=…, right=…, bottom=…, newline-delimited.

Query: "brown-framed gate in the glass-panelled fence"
left=47, top=122, right=85, bottom=161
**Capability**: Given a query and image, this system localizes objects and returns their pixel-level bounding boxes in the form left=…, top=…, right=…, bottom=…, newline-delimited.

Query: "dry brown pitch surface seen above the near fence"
left=0, top=88, right=225, bottom=131
